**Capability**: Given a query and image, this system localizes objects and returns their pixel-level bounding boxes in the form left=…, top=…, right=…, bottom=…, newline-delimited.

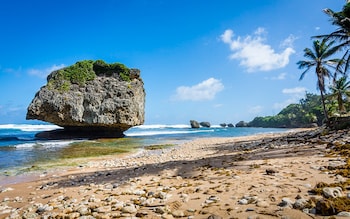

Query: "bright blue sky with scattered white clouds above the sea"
left=0, top=0, right=345, bottom=124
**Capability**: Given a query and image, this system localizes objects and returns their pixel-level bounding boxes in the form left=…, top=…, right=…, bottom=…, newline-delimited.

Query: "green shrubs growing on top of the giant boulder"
left=48, top=60, right=131, bottom=91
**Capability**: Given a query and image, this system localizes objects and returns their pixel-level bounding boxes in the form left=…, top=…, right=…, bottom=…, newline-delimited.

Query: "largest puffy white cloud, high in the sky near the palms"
left=220, top=27, right=296, bottom=72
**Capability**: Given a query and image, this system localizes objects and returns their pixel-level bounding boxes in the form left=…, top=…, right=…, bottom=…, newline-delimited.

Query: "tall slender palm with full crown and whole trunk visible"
left=297, top=38, right=340, bottom=124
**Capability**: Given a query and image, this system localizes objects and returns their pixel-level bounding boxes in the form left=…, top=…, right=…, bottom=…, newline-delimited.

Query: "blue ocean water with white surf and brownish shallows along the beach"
left=0, top=124, right=288, bottom=176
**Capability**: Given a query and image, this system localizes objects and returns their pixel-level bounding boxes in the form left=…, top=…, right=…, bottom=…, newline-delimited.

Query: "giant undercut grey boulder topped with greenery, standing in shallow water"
left=26, top=60, right=145, bottom=138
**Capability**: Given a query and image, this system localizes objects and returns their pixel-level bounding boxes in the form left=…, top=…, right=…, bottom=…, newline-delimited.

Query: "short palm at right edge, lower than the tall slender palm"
left=330, top=76, right=350, bottom=113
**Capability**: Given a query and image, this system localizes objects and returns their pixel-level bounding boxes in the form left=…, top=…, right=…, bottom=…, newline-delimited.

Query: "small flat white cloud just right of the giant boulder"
left=174, top=78, right=224, bottom=101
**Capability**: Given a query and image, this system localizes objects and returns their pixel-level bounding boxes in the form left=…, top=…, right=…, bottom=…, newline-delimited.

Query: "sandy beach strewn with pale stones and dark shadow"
left=0, top=129, right=350, bottom=219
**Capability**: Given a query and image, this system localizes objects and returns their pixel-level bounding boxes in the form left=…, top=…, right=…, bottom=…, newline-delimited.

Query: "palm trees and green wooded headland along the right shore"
left=248, top=1, right=350, bottom=128
